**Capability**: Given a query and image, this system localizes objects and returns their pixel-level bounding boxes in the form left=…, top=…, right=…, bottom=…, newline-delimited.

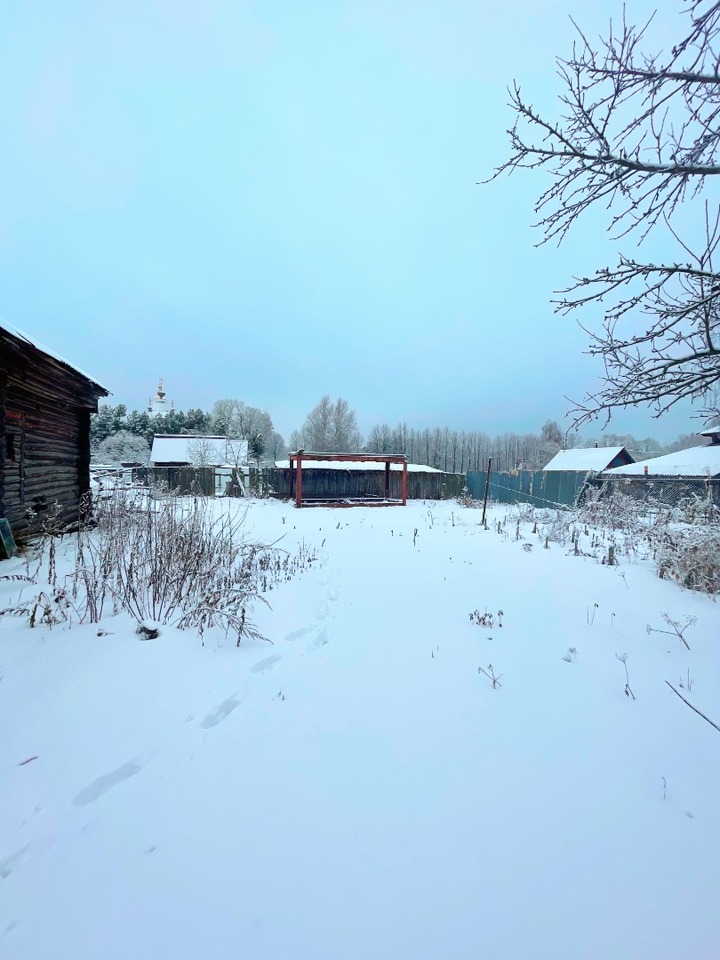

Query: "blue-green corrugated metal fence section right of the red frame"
left=467, top=470, right=592, bottom=507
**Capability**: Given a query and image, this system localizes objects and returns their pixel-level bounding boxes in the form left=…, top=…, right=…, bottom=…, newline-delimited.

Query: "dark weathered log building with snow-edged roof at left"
left=0, top=321, right=109, bottom=541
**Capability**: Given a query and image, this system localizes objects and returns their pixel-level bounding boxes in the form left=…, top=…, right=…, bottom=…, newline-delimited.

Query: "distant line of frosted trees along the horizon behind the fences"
left=91, top=395, right=698, bottom=473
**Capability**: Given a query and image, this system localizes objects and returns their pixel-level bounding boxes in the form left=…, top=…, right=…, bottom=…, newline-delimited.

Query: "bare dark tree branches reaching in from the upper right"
left=491, top=0, right=720, bottom=424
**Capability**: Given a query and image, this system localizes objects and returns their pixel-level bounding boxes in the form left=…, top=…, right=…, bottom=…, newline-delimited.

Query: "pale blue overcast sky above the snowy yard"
left=0, top=0, right=698, bottom=439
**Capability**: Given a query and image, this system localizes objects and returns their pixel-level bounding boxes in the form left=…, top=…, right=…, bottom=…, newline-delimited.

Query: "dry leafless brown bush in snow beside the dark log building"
left=70, top=490, right=315, bottom=643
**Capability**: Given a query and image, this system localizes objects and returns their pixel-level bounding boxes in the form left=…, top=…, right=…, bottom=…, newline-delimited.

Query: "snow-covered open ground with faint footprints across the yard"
left=0, top=501, right=720, bottom=960
